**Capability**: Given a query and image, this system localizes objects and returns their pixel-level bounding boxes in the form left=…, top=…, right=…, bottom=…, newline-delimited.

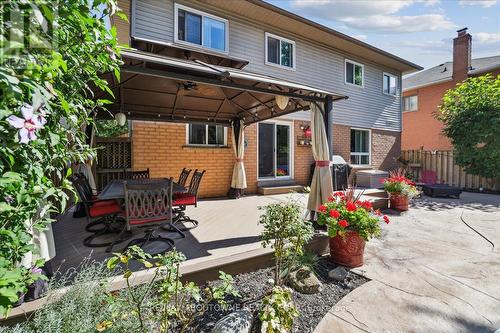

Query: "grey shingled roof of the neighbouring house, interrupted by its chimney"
left=403, top=55, right=500, bottom=91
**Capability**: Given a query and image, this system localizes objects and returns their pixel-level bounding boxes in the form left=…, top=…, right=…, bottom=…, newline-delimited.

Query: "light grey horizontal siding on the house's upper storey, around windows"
left=132, top=0, right=401, bottom=131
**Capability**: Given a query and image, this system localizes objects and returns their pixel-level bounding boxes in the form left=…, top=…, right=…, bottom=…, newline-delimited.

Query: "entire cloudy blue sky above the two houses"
left=266, top=0, right=500, bottom=68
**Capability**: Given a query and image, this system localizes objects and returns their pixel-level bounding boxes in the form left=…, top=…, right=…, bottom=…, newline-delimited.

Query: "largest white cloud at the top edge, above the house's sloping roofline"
left=292, top=0, right=455, bottom=33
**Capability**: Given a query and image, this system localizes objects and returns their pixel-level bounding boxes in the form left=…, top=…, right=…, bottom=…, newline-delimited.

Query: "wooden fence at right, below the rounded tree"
left=401, top=150, right=500, bottom=191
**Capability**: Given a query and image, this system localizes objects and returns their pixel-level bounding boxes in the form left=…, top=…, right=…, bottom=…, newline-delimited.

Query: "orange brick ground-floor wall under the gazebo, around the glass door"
left=131, top=121, right=313, bottom=197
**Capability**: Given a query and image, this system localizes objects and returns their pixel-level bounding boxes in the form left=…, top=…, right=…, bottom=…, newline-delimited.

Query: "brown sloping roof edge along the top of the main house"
left=201, top=0, right=422, bottom=73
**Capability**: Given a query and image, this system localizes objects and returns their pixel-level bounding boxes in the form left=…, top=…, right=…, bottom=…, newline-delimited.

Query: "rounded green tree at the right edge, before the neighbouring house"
left=436, top=74, right=500, bottom=178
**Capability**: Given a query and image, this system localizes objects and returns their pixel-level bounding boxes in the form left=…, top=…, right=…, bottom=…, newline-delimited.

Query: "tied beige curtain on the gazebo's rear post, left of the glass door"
left=229, top=120, right=247, bottom=198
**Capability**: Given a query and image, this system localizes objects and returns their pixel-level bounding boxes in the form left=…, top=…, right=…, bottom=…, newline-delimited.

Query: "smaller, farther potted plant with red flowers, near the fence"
left=384, top=169, right=420, bottom=211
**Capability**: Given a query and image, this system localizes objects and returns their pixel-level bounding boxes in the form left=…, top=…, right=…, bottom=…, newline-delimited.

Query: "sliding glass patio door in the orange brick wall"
left=258, top=122, right=292, bottom=178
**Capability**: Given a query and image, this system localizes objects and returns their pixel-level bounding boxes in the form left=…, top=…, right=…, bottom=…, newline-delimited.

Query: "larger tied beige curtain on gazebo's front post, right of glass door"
left=307, top=103, right=333, bottom=211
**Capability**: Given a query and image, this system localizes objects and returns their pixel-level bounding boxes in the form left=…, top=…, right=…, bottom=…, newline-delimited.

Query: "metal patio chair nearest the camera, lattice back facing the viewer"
left=106, top=178, right=174, bottom=255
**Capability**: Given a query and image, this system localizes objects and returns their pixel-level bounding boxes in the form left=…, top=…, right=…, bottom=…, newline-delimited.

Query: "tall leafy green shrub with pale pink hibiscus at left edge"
left=0, top=0, right=119, bottom=314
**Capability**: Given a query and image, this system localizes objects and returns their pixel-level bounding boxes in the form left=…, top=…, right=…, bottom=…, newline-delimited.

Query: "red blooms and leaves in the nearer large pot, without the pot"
left=318, top=188, right=389, bottom=241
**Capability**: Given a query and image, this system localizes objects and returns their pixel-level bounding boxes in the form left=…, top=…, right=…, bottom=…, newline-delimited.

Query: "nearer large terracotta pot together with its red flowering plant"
left=318, top=188, right=389, bottom=267
